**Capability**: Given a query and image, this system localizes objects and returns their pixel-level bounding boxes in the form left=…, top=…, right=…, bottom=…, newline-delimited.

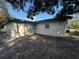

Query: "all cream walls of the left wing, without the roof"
left=5, top=23, right=33, bottom=38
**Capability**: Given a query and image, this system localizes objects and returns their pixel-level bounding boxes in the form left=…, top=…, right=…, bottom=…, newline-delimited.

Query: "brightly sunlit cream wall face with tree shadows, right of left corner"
left=11, top=23, right=33, bottom=37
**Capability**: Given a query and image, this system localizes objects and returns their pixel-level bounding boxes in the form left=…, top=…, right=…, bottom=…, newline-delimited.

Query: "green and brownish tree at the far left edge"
left=0, top=0, right=10, bottom=30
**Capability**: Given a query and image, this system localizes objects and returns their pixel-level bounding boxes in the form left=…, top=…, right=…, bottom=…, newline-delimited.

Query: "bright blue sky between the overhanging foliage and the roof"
left=7, top=3, right=62, bottom=21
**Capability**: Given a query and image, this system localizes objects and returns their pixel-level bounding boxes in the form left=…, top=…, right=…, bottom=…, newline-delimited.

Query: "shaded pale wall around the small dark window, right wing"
left=36, top=21, right=66, bottom=36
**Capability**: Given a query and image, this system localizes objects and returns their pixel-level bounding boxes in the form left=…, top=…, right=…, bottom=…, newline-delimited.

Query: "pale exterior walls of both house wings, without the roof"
left=4, top=21, right=66, bottom=38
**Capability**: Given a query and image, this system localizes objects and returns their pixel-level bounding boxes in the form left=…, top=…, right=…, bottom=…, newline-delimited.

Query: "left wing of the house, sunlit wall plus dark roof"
left=4, top=19, right=33, bottom=37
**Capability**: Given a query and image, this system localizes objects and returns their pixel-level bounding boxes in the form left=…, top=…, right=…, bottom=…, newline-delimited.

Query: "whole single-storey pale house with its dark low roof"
left=4, top=17, right=72, bottom=37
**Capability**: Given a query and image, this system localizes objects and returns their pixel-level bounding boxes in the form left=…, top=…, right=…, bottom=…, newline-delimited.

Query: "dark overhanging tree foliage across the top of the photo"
left=6, top=0, right=79, bottom=18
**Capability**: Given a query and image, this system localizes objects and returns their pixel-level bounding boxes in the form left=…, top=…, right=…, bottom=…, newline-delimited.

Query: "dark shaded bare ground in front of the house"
left=0, top=34, right=79, bottom=59
